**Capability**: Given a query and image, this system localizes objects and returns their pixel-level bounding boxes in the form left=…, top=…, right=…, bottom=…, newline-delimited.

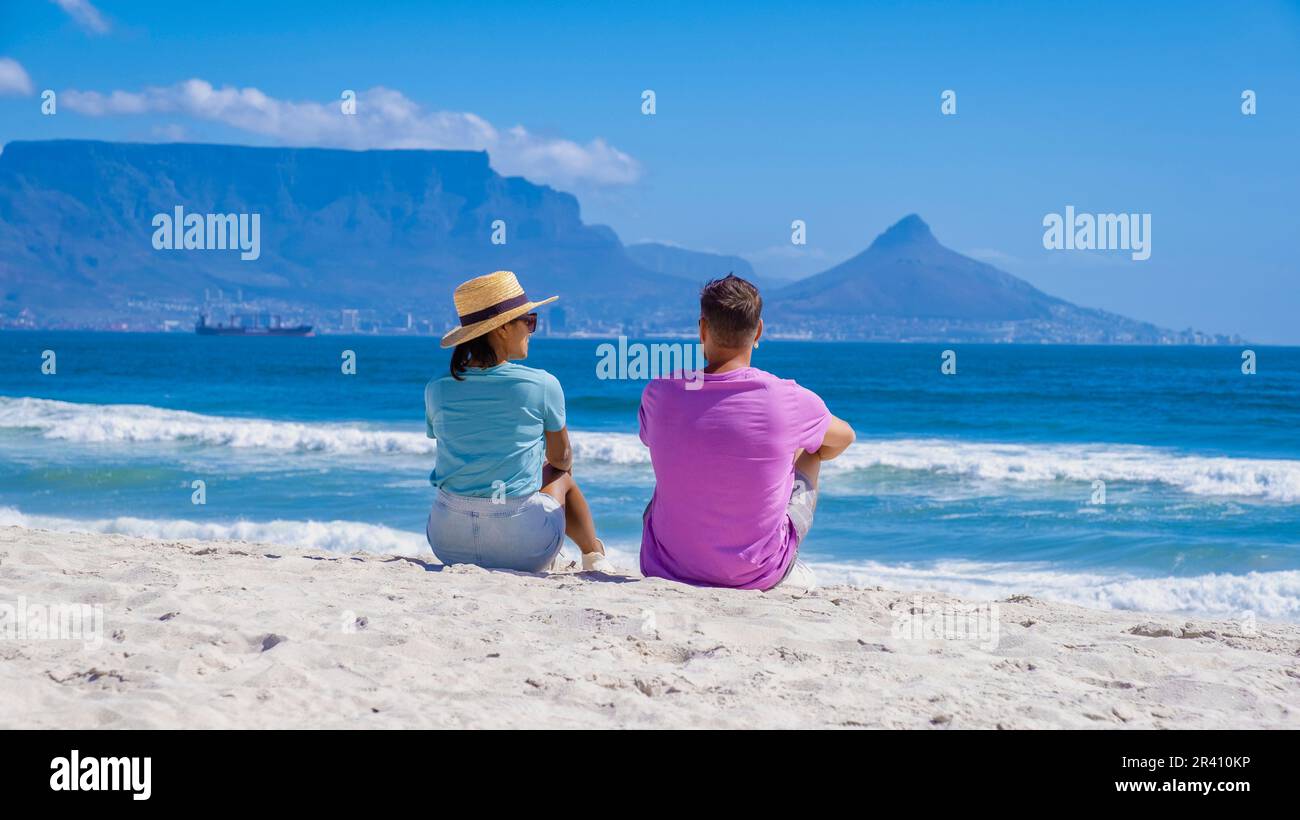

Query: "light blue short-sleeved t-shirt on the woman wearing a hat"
left=424, top=361, right=564, bottom=498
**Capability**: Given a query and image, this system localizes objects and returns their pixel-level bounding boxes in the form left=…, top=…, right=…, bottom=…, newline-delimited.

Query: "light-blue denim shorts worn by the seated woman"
left=425, top=490, right=564, bottom=572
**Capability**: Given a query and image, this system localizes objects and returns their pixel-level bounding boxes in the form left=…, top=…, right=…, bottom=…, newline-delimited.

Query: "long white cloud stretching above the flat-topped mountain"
left=59, top=79, right=641, bottom=185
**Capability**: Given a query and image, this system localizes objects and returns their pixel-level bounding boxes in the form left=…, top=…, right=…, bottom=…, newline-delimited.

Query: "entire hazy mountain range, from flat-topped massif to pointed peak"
left=0, top=140, right=1227, bottom=343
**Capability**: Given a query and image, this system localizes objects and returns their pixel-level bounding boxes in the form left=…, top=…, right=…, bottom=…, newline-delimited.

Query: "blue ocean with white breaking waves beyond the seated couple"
left=0, top=331, right=1300, bottom=621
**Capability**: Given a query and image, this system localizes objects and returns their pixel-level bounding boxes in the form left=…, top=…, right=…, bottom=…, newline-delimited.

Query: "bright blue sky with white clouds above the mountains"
left=0, top=0, right=1300, bottom=343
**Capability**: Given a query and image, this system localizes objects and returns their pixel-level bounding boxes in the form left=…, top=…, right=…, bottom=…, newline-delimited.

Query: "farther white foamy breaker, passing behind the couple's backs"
left=0, top=396, right=1300, bottom=503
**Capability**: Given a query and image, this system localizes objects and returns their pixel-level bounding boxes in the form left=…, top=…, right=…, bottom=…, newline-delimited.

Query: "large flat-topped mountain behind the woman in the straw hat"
left=0, top=140, right=689, bottom=330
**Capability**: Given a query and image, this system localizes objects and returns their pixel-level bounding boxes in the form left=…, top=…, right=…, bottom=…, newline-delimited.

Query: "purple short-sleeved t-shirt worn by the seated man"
left=641, top=368, right=831, bottom=590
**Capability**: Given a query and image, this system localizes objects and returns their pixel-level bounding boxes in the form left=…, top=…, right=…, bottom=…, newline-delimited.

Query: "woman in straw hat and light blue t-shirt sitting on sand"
left=424, top=270, right=612, bottom=572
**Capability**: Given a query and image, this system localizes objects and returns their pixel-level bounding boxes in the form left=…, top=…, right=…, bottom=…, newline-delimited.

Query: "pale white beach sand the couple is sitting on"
left=0, top=528, right=1300, bottom=728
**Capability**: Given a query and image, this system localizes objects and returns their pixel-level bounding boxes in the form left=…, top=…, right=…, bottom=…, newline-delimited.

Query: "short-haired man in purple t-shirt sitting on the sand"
left=641, top=275, right=854, bottom=590
